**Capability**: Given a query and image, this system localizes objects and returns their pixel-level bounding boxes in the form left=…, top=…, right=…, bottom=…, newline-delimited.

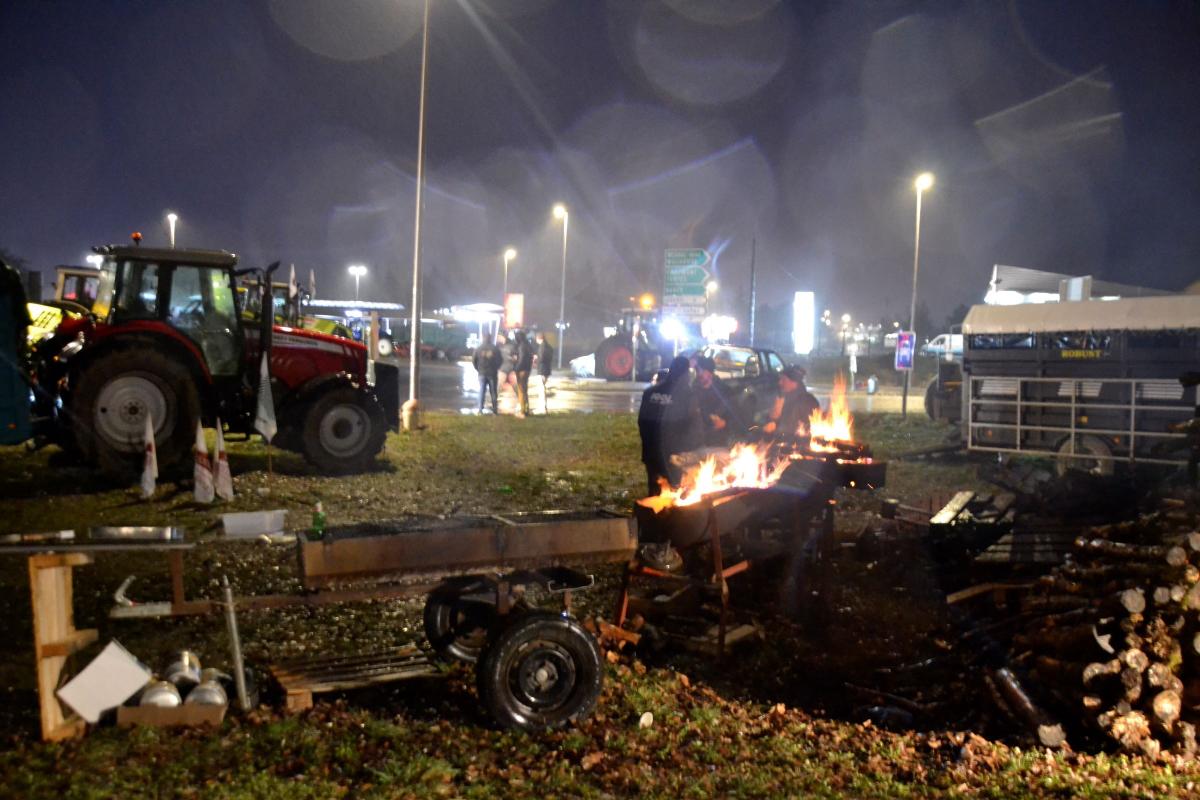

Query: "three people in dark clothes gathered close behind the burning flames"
left=637, top=355, right=821, bottom=495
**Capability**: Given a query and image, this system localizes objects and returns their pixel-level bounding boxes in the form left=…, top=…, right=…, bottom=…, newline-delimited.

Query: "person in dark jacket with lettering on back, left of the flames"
left=637, top=355, right=700, bottom=497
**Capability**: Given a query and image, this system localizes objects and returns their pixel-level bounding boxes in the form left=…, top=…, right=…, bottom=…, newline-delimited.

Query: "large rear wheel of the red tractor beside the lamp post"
left=72, top=348, right=200, bottom=477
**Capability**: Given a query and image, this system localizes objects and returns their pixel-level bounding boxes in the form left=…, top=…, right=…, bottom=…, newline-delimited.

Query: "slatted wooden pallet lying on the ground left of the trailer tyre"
left=268, top=645, right=438, bottom=711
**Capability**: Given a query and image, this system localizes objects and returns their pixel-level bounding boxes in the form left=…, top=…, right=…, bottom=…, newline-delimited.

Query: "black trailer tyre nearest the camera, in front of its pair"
left=476, top=610, right=604, bottom=730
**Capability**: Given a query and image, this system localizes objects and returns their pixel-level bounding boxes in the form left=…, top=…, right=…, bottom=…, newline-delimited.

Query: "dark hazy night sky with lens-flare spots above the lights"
left=0, top=0, right=1200, bottom=333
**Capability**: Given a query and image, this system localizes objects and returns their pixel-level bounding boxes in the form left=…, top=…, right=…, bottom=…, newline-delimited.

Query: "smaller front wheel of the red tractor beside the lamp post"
left=304, top=386, right=388, bottom=474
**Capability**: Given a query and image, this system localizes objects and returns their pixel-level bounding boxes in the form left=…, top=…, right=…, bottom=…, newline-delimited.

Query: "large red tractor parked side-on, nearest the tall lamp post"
left=34, top=245, right=400, bottom=476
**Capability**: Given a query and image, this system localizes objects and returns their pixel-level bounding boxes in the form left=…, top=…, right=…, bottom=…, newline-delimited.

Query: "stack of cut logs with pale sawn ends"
left=991, top=512, right=1200, bottom=758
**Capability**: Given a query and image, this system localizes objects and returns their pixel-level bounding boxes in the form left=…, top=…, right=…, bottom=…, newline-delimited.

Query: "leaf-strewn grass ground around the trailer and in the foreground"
left=0, top=414, right=1200, bottom=798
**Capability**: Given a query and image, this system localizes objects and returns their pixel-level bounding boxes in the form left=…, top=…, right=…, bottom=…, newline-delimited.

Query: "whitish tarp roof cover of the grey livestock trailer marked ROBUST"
left=962, top=295, right=1200, bottom=335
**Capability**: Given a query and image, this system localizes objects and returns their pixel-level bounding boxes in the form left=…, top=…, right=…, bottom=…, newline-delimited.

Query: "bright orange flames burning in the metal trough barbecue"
left=637, top=375, right=871, bottom=513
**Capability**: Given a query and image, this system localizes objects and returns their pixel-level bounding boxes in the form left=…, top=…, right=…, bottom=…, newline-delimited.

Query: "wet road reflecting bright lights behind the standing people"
left=401, top=361, right=907, bottom=414
